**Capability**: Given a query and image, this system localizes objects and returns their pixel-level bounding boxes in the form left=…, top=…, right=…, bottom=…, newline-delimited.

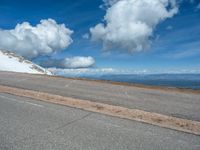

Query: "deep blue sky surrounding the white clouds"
left=0, top=0, right=200, bottom=73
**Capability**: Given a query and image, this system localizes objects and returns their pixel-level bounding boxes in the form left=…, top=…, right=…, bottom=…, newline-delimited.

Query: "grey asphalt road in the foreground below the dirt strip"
left=0, top=94, right=200, bottom=150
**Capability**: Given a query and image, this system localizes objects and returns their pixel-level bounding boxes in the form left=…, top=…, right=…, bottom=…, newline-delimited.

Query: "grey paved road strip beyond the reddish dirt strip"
left=0, top=72, right=200, bottom=121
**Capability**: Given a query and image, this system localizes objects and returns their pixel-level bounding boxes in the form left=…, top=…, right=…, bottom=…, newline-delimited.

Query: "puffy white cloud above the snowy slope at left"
left=0, top=19, right=73, bottom=58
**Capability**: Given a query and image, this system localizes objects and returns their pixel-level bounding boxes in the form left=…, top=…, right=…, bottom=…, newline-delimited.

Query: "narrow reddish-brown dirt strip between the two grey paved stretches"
left=0, top=85, right=200, bottom=135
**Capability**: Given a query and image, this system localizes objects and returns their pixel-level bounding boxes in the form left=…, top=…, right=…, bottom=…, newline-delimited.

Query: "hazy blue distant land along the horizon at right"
left=90, top=74, right=200, bottom=89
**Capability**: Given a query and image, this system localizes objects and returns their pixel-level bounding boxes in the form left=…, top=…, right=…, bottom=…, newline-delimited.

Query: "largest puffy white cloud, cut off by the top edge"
left=90, top=0, right=178, bottom=52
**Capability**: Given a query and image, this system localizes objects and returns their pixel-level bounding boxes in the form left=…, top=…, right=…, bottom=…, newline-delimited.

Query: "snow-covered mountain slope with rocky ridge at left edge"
left=0, top=50, right=52, bottom=75
